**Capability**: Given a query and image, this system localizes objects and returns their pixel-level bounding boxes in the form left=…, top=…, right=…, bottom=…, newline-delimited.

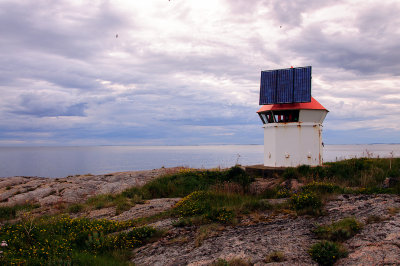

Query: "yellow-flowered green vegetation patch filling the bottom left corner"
left=0, top=216, right=160, bottom=265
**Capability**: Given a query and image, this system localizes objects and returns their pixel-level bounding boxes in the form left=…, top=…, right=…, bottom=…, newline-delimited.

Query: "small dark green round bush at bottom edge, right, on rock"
left=308, top=240, right=347, bottom=265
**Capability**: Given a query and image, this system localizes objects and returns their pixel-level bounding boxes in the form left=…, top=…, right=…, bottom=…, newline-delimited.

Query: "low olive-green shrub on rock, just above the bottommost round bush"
left=314, top=218, right=362, bottom=241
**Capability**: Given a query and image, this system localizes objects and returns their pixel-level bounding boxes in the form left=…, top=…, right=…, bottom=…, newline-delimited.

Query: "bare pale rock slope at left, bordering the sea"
left=0, top=167, right=181, bottom=206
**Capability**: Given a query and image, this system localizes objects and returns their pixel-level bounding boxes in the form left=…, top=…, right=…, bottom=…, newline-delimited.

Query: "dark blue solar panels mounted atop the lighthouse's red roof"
left=260, top=66, right=311, bottom=105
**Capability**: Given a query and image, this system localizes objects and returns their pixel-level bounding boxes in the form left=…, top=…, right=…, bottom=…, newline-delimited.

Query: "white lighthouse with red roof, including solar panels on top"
left=257, top=66, right=328, bottom=167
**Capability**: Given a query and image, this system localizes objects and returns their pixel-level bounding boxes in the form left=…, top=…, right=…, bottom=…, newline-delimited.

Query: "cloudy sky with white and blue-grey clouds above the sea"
left=0, top=0, right=400, bottom=146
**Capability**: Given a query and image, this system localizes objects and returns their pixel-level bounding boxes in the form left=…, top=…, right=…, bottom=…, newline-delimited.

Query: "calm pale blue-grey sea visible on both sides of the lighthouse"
left=0, top=144, right=400, bottom=178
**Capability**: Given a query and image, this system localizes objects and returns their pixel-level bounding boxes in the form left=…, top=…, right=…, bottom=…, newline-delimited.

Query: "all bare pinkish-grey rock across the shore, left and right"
left=0, top=168, right=400, bottom=265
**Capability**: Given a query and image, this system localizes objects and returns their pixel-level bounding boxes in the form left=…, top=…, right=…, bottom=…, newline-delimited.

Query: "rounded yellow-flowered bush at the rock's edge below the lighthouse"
left=290, top=192, right=322, bottom=214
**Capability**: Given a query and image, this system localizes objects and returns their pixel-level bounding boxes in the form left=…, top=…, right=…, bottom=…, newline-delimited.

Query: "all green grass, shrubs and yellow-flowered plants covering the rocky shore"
left=0, top=158, right=400, bottom=265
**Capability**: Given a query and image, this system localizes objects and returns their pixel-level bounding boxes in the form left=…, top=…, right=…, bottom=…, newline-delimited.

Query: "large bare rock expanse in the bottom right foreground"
left=132, top=195, right=400, bottom=265
